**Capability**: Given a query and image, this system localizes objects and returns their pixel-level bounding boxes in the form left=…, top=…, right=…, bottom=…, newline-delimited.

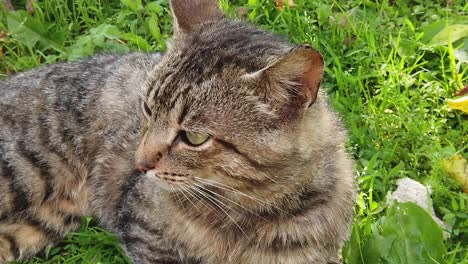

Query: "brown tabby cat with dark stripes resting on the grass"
left=0, top=0, right=355, bottom=264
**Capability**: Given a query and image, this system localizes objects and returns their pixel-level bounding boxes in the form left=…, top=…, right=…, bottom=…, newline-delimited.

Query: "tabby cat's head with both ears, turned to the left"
left=136, top=0, right=324, bottom=197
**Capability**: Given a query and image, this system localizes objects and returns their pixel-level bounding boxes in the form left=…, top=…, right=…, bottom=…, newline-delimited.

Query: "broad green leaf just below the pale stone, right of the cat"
left=350, top=202, right=445, bottom=264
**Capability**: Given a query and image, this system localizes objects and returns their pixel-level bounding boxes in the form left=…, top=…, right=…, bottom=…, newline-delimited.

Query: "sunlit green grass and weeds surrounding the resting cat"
left=0, top=0, right=468, bottom=263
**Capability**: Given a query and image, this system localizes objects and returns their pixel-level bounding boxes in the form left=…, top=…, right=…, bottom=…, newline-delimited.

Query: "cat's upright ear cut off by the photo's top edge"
left=171, top=0, right=224, bottom=33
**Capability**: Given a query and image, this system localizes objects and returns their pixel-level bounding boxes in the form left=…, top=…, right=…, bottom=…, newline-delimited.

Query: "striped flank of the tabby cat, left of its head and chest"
left=0, top=54, right=160, bottom=262
